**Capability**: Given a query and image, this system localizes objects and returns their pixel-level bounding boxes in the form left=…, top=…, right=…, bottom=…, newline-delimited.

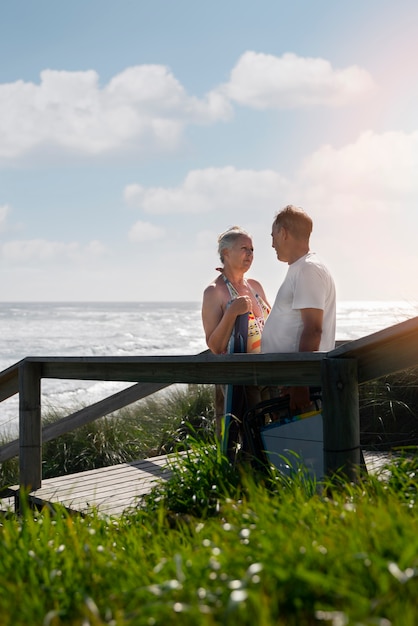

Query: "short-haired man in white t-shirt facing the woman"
left=261, top=205, right=336, bottom=412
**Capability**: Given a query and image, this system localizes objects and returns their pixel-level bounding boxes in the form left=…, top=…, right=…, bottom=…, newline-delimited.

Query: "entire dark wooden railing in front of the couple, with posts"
left=0, top=317, right=418, bottom=489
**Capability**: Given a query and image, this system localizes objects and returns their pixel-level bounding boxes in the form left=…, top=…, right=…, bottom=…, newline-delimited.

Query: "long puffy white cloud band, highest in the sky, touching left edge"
left=0, top=52, right=373, bottom=160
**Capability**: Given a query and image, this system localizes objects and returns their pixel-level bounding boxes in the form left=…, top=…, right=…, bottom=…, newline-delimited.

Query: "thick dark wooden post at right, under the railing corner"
left=321, top=357, right=360, bottom=481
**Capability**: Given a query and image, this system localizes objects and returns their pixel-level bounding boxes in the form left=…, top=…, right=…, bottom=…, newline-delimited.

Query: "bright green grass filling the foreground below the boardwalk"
left=0, top=444, right=418, bottom=626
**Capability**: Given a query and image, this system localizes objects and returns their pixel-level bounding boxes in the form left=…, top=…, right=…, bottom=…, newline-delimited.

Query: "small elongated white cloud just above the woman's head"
left=124, top=167, right=287, bottom=215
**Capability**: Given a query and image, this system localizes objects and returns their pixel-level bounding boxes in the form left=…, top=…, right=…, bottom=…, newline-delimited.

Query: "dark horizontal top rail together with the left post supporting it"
left=13, top=352, right=324, bottom=489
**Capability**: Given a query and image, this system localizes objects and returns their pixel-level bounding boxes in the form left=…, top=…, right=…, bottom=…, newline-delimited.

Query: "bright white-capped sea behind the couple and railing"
left=0, top=301, right=418, bottom=434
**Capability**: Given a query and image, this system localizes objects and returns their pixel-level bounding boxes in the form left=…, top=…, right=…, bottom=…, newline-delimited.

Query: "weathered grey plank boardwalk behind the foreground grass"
left=3, top=455, right=177, bottom=516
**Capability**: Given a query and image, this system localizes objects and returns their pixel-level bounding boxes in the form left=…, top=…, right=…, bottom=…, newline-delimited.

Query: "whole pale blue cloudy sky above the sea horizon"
left=0, top=0, right=418, bottom=303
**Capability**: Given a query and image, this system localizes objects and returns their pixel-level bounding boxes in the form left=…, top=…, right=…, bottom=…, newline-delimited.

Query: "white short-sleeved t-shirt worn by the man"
left=261, top=252, right=336, bottom=352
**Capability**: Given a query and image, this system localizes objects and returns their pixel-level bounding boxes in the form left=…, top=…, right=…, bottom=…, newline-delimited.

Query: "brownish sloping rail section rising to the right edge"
left=327, top=317, right=418, bottom=383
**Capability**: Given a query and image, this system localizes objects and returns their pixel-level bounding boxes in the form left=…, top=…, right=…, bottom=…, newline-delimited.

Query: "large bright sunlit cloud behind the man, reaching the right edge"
left=280, top=131, right=418, bottom=300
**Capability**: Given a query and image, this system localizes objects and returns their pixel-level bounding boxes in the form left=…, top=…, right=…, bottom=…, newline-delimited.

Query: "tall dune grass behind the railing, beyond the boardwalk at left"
left=0, top=385, right=215, bottom=488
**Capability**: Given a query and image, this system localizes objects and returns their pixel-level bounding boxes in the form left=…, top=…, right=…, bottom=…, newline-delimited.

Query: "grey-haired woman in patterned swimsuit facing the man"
left=202, top=226, right=270, bottom=448
